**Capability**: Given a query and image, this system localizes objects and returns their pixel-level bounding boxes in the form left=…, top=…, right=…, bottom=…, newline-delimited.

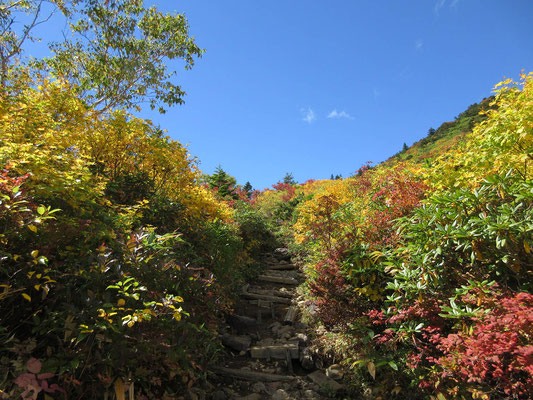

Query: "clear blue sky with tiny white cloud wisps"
left=27, top=0, right=533, bottom=189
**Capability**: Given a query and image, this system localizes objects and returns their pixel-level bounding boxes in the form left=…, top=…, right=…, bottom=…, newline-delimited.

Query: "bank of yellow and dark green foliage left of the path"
left=0, top=69, right=261, bottom=398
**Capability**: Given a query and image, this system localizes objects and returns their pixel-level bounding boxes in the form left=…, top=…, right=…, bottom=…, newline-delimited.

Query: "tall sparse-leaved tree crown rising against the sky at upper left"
left=0, top=0, right=203, bottom=112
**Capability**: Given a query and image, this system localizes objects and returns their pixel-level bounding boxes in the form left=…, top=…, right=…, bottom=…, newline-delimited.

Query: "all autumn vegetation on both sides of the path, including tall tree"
left=0, top=1, right=533, bottom=400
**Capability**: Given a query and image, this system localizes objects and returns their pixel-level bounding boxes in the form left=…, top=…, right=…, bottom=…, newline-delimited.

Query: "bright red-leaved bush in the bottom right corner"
left=437, top=292, right=533, bottom=398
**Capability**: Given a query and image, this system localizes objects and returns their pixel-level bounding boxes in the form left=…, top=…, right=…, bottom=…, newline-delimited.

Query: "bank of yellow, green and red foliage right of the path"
left=294, top=74, right=533, bottom=399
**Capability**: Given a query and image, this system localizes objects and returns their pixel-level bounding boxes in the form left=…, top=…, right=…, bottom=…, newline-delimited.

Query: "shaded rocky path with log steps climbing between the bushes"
left=204, top=249, right=343, bottom=400
